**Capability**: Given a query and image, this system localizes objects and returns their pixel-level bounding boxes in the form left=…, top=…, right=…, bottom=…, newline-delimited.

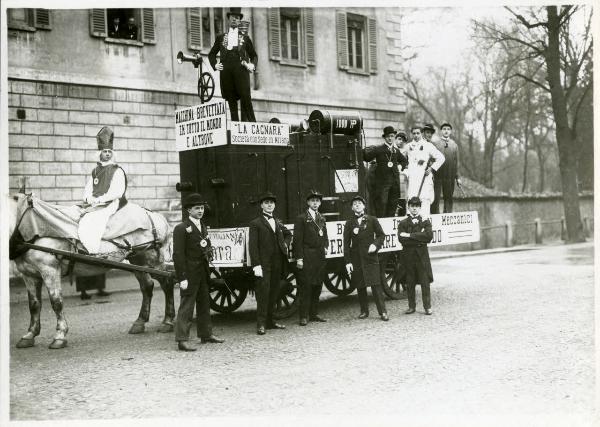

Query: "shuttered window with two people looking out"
left=90, top=9, right=156, bottom=46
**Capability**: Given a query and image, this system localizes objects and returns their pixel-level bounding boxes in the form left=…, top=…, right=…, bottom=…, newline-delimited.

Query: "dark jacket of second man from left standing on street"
left=249, top=214, right=292, bottom=268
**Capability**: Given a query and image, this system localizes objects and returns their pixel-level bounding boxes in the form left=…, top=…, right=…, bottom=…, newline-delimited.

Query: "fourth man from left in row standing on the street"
left=344, top=195, right=389, bottom=322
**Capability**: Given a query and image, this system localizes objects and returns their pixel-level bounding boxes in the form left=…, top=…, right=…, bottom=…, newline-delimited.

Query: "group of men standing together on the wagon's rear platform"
left=363, top=122, right=460, bottom=217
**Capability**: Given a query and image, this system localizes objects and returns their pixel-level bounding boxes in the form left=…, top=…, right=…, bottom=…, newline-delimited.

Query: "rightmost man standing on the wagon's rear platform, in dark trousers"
left=431, top=122, right=460, bottom=213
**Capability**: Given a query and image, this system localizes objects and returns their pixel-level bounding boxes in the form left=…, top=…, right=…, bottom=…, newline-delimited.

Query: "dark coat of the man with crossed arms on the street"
left=398, top=215, right=433, bottom=284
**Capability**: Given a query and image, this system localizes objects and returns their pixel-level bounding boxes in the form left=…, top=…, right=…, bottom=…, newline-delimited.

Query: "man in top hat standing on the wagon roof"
left=208, top=7, right=258, bottom=122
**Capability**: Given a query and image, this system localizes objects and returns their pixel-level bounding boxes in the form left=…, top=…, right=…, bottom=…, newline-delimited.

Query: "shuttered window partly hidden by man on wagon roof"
left=187, top=7, right=227, bottom=53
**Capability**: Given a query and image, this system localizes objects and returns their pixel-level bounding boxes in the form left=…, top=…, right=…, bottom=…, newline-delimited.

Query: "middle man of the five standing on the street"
left=293, top=190, right=329, bottom=326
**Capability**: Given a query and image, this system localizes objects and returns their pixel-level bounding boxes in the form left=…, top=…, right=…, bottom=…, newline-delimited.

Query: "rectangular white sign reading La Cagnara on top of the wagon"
left=229, top=122, right=290, bottom=146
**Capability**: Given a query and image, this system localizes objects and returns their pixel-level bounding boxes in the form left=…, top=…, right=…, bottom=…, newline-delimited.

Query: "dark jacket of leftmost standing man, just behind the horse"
left=173, top=219, right=212, bottom=290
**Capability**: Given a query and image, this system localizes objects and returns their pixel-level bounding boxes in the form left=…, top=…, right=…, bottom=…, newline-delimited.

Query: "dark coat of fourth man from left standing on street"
left=344, top=215, right=385, bottom=288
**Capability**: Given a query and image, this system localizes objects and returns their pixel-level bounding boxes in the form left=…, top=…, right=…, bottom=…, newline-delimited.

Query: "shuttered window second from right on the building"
left=268, top=7, right=315, bottom=67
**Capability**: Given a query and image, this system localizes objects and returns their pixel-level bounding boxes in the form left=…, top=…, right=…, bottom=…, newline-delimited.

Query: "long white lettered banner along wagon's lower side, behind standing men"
left=209, top=211, right=479, bottom=267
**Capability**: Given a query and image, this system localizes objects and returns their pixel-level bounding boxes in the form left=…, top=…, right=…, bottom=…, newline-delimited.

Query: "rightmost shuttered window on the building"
left=336, top=11, right=377, bottom=75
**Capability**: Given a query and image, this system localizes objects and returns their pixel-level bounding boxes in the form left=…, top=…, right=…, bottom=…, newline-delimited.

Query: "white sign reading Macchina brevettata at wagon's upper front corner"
left=175, top=100, right=227, bottom=151
